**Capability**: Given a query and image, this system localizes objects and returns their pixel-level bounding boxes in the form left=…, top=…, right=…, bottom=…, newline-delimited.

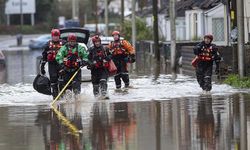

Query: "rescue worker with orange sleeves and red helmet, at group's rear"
left=108, top=31, right=135, bottom=90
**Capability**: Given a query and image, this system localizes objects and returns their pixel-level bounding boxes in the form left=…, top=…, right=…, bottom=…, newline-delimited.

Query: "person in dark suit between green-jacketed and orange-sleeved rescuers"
left=88, top=35, right=111, bottom=99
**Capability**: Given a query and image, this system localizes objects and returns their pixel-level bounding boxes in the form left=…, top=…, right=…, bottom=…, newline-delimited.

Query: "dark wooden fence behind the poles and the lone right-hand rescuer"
left=136, top=41, right=250, bottom=78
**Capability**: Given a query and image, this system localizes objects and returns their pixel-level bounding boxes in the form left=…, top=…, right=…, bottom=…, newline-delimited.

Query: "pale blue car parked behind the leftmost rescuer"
left=29, top=34, right=51, bottom=50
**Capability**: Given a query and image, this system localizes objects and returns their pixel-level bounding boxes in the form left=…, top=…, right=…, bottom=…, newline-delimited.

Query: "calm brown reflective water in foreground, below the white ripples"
left=0, top=94, right=244, bottom=150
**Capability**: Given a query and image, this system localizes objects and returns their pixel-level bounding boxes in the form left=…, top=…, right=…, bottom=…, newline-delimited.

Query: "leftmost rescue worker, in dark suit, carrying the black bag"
left=40, top=29, right=65, bottom=98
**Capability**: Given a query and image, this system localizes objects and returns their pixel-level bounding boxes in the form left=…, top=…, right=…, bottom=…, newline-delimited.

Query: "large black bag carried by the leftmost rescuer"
left=33, top=74, right=51, bottom=95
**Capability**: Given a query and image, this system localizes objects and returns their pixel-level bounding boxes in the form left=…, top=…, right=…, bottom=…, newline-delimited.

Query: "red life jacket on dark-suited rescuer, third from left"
left=92, top=47, right=109, bottom=68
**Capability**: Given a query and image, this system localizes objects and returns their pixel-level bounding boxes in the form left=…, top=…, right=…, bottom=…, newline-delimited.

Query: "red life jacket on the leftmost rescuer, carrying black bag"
left=47, top=41, right=63, bottom=62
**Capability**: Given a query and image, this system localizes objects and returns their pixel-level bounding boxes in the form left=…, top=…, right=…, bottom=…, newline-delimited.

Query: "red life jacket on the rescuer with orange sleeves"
left=110, top=40, right=128, bottom=56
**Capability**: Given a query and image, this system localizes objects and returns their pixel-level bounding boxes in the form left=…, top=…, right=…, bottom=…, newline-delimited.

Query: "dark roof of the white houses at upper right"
left=133, top=0, right=225, bottom=17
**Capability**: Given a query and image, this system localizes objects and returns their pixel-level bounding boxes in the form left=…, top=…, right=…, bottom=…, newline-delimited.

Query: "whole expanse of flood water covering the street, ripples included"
left=0, top=51, right=250, bottom=150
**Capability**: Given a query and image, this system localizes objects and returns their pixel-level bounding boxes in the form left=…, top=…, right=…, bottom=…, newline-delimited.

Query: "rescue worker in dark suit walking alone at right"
left=192, top=34, right=221, bottom=93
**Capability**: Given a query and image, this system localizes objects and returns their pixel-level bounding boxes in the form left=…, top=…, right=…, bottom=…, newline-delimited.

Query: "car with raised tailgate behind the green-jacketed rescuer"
left=60, top=28, right=91, bottom=82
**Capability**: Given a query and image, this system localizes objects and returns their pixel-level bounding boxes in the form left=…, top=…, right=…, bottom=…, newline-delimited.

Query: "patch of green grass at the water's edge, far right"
left=224, top=74, right=250, bottom=88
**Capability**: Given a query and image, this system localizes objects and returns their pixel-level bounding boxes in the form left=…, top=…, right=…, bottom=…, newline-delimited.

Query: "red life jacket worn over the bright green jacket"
left=63, top=45, right=80, bottom=69
